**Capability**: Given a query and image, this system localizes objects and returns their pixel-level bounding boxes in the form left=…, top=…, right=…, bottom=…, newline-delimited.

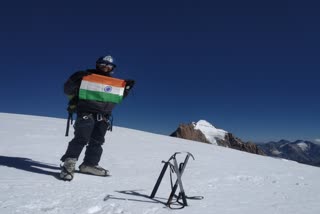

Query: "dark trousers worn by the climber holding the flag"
left=61, top=114, right=110, bottom=166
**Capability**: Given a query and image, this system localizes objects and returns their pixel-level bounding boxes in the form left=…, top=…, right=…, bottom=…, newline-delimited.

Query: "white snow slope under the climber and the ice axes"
left=0, top=113, right=320, bottom=214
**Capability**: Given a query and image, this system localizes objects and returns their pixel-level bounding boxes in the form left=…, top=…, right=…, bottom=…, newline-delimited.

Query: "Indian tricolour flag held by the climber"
left=79, top=74, right=126, bottom=103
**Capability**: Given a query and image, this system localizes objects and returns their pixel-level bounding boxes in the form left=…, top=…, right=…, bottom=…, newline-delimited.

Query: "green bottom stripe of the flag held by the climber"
left=79, top=89, right=122, bottom=103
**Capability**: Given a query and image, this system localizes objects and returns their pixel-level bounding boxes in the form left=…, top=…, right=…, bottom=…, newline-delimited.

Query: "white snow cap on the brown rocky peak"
left=193, top=120, right=227, bottom=145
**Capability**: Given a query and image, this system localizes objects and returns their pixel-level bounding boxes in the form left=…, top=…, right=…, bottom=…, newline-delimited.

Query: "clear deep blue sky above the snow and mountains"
left=0, top=0, right=320, bottom=142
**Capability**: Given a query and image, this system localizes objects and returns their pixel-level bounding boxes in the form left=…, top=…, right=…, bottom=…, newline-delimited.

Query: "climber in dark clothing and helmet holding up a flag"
left=60, top=55, right=135, bottom=181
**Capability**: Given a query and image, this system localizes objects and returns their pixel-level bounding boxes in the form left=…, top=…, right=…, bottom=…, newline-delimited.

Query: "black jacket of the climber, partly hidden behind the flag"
left=64, top=69, right=122, bottom=115
